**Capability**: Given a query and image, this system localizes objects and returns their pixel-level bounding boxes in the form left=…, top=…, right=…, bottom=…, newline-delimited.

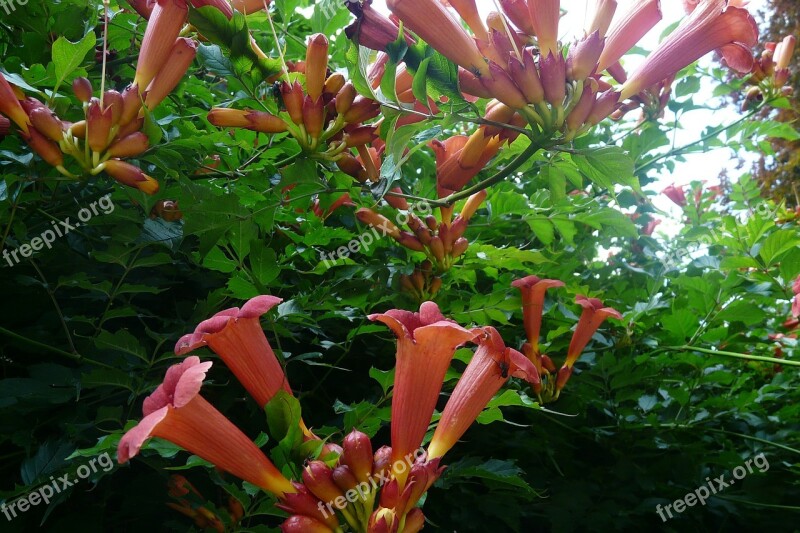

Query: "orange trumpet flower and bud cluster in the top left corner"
left=0, top=0, right=220, bottom=194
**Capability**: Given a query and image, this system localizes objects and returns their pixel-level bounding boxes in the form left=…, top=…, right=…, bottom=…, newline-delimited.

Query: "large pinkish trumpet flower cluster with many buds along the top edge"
left=360, top=0, right=758, bottom=141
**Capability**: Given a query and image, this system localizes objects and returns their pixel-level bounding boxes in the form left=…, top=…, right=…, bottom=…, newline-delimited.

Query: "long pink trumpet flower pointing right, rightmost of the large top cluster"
left=620, top=0, right=758, bottom=100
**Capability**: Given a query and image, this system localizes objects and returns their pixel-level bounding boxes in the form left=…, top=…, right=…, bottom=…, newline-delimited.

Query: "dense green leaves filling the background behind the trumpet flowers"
left=0, top=0, right=800, bottom=532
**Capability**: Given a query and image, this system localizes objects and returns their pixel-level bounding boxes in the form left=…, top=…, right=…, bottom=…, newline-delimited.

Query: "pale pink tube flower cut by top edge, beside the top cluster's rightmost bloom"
left=597, top=0, right=661, bottom=72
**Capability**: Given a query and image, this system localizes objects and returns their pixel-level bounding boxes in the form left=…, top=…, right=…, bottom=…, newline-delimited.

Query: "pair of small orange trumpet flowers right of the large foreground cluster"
left=511, top=276, right=622, bottom=403
